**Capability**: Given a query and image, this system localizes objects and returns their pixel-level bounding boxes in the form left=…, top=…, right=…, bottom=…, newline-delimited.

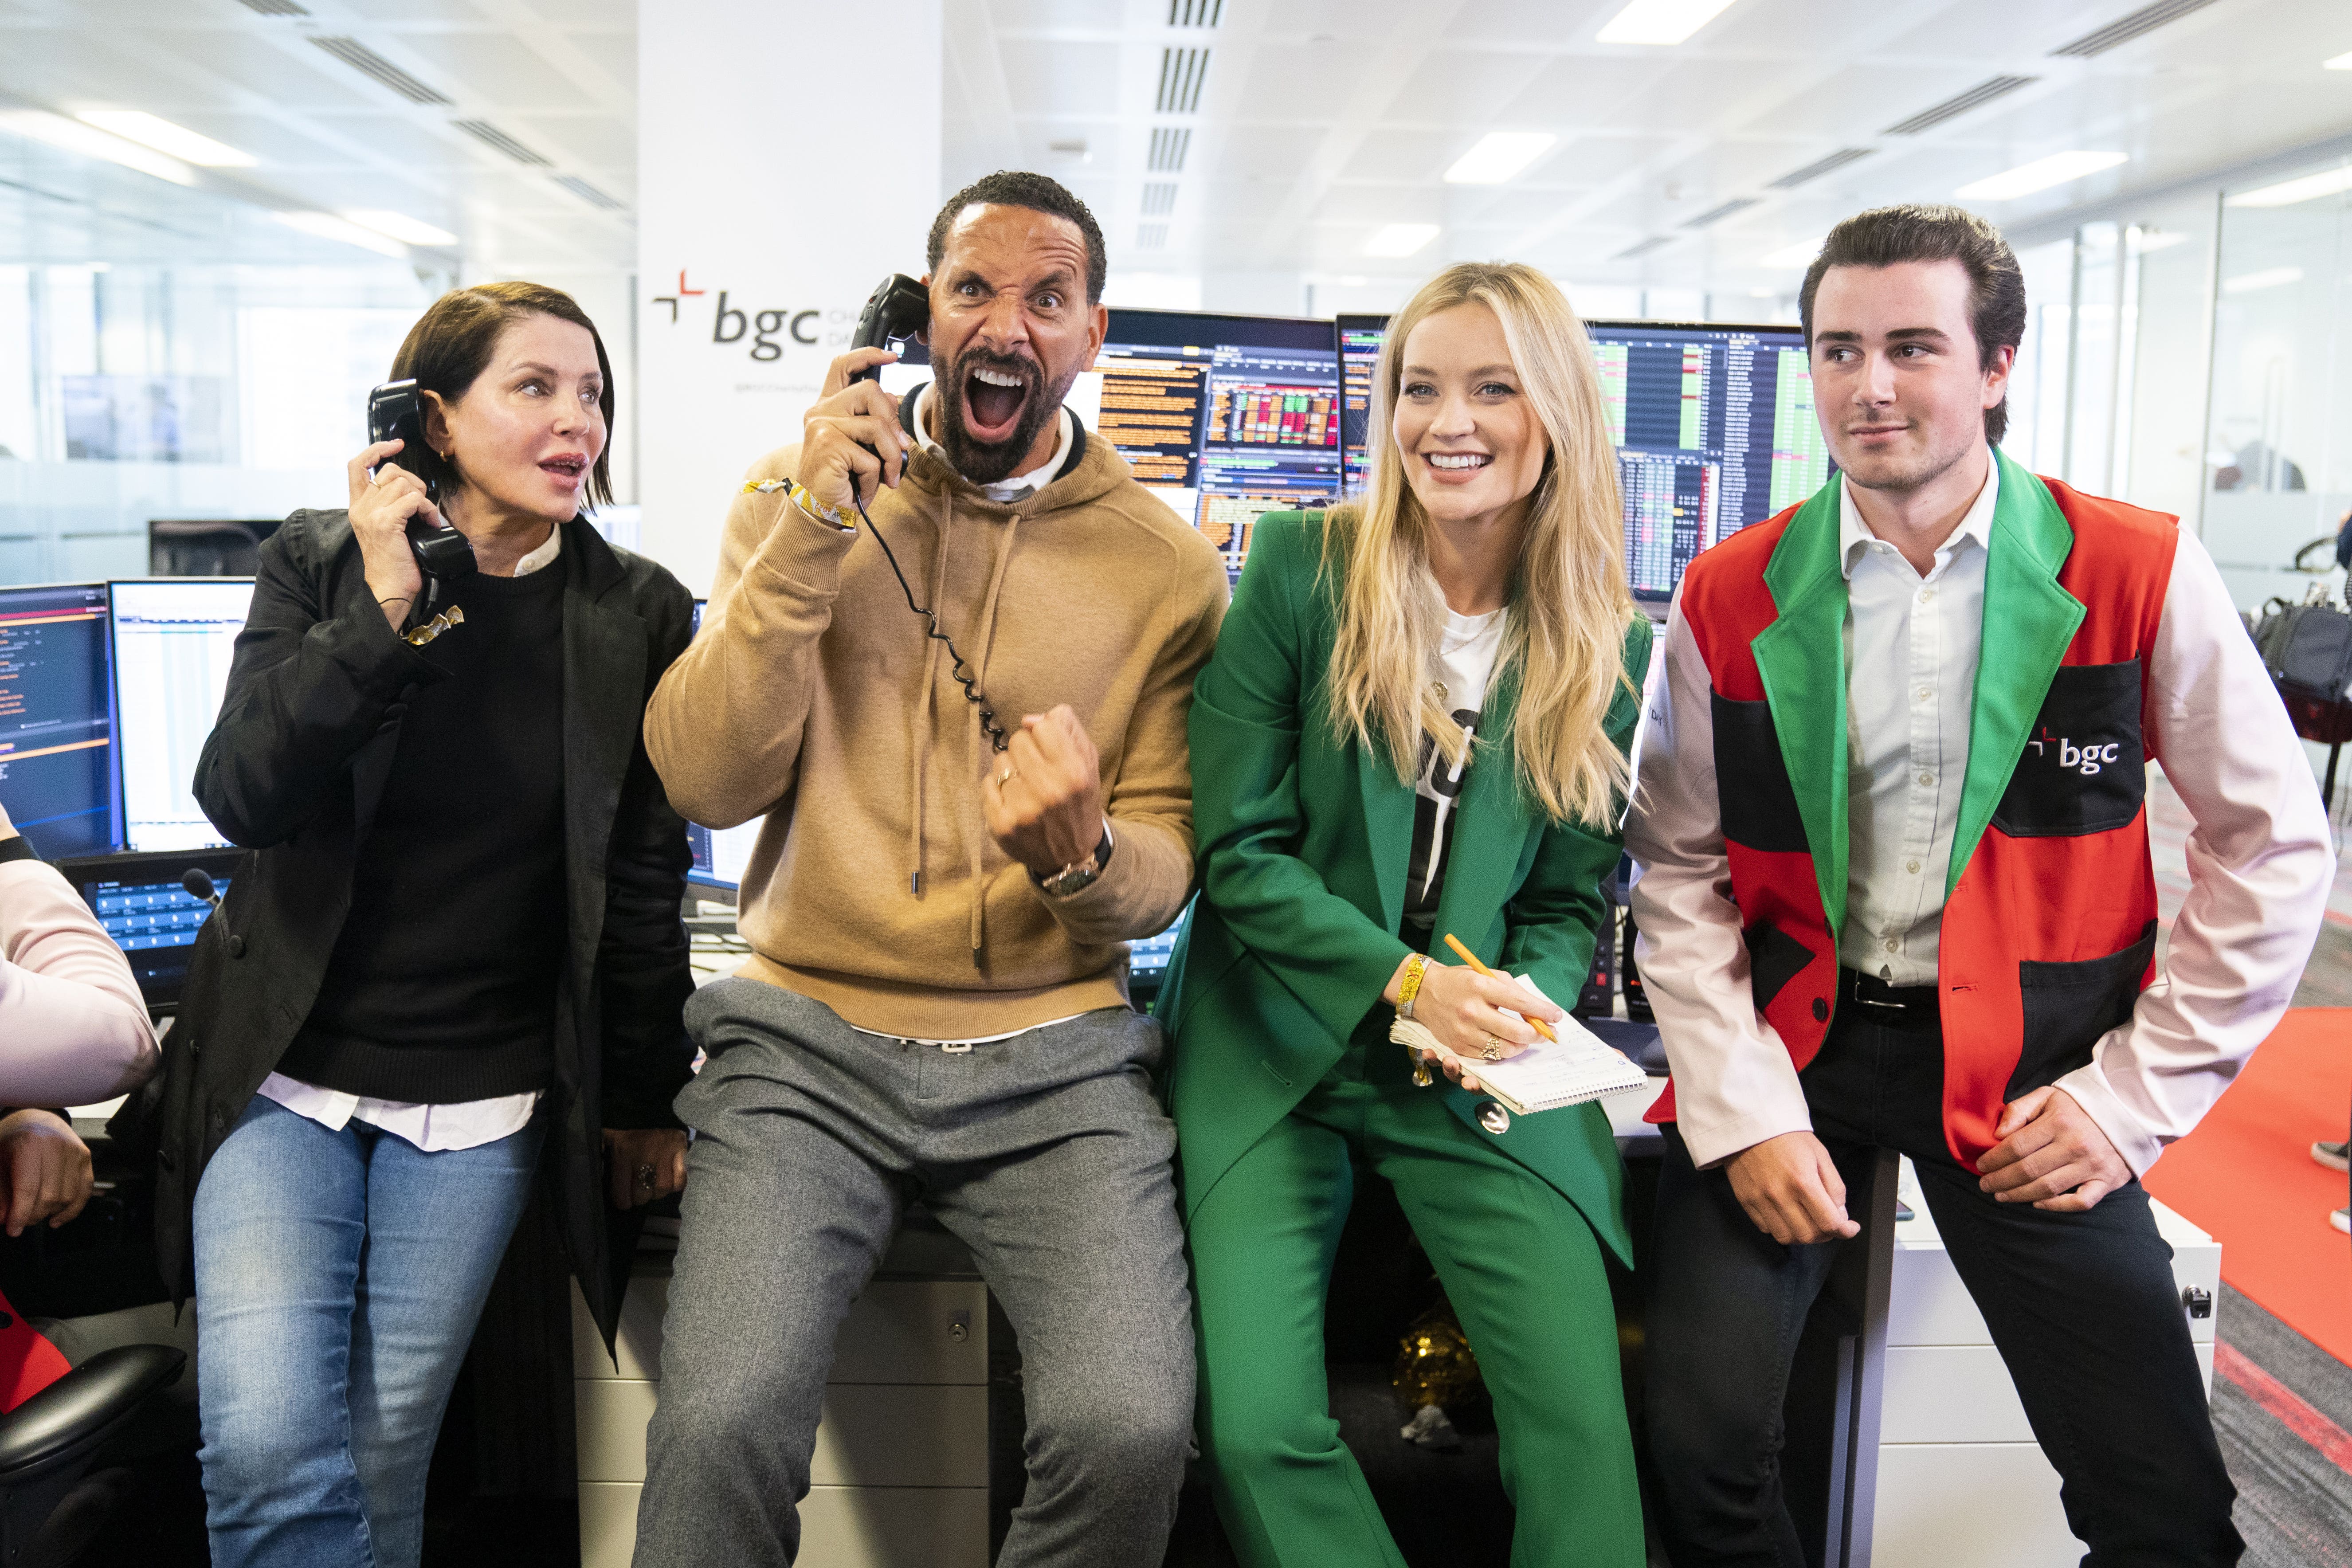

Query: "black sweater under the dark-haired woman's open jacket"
left=278, top=564, right=564, bottom=1105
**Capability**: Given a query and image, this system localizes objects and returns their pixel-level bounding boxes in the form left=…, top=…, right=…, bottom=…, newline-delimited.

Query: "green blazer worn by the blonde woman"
left=1157, top=513, right=1651, bottom=1262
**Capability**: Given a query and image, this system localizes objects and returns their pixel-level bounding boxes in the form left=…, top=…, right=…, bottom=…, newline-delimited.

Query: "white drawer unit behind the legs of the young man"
left=1870, top=1161, right=2220, bottom=1568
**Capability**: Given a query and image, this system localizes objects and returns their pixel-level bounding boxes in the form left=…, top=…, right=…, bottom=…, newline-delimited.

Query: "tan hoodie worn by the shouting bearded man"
left=644, top=416, right=1225, bottom=1039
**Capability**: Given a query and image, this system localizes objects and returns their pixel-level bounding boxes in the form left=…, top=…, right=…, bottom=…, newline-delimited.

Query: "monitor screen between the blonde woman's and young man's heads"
left=1343, top=318, right=1832, bottom=607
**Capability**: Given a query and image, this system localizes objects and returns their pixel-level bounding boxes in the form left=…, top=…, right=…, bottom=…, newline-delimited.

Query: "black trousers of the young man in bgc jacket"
left=1646, top=1004, right=2244, bottom=1568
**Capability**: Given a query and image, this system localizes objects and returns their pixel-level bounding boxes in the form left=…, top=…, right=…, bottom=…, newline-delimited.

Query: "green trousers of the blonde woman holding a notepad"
left=1190, top=1051, right=1644, bottom=1568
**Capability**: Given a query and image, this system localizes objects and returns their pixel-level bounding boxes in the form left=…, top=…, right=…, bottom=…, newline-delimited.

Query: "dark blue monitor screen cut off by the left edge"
left=0, top=583, right=120, bottom=860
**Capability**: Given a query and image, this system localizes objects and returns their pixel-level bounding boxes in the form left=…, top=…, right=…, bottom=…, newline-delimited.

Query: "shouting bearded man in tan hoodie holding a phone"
left=637, top=174, right=1225, bottom=1568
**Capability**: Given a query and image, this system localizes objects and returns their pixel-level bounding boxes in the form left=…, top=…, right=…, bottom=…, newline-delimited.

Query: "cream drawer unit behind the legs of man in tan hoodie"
left=572, top=1255, right=988, bottom=1568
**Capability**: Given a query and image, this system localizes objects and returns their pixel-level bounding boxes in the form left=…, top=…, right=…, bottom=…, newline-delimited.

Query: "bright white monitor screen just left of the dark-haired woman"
left=110, top=578, right=254, bottom=851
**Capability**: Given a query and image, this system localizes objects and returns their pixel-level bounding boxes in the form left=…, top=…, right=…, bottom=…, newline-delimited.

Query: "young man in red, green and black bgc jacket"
left=1625, top=207, right=2333, bottom=1568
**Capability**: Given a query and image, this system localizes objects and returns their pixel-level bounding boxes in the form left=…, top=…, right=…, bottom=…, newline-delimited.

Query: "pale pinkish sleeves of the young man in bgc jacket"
left=1625, top=479, right=2336, bottom=1173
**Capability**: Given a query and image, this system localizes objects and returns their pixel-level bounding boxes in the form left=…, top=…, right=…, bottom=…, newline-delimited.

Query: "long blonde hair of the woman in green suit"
left=1322, top=263, right=1639, bottom=827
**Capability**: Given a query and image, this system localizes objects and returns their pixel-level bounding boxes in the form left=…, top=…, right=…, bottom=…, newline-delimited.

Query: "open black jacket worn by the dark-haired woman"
left=155, top=510, right=694, bottom=1340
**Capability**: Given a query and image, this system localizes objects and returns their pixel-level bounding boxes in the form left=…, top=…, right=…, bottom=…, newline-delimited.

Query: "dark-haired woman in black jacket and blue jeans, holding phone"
left=157, top=282, right=694, bottom=1568
